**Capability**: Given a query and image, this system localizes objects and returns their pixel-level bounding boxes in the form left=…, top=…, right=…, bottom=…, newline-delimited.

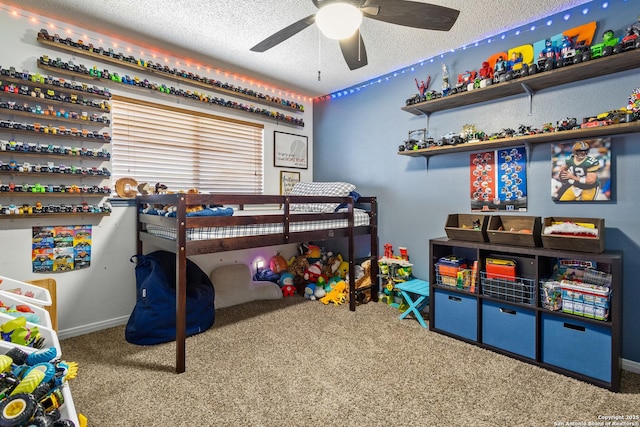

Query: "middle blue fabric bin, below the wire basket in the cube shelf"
left=482, top=300, right=536, bottom=359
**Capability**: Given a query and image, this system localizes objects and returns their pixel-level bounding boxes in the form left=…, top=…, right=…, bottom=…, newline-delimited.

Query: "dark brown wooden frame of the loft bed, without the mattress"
left=137, top=194, right=378, bottom=373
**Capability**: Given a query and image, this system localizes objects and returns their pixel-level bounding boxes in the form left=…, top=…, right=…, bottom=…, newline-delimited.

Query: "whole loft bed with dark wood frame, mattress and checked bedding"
left=137, top=187, right=378, bottom=373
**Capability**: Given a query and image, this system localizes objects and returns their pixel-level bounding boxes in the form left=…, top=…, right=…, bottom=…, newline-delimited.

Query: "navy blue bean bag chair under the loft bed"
left=125, top=251, right=215, bottom=345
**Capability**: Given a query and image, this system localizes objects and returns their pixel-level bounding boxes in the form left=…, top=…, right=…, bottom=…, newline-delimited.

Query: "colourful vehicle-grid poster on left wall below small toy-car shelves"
left=31, top=225, right=91, bottom=273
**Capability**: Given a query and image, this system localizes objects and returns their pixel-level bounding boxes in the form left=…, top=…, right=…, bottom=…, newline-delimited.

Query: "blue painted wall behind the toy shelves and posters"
left=313, top=0, right=640, bottom=363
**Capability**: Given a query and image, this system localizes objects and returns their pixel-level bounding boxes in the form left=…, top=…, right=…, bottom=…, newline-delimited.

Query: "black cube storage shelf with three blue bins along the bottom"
left=429, top=237, right=622, bottom=391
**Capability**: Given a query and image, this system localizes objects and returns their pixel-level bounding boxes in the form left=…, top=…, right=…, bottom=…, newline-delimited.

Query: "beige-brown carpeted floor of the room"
left=61, top=296, right=640, bottom=427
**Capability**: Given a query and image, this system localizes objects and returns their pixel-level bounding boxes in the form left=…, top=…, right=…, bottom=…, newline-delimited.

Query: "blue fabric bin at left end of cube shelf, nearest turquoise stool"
left=433, top=288, right=478, bottom=341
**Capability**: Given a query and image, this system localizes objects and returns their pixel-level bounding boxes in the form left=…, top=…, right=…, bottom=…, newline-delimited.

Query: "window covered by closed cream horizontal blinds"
left=111, top=96, right=264, bottom=194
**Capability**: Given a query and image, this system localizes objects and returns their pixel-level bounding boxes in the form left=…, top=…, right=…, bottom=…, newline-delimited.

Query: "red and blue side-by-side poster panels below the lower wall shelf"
left=470, top=147, right=527, bottom=212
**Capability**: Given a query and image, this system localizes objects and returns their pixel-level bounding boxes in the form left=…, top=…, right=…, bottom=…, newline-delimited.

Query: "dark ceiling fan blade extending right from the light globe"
left=361, top=0, right=460, bottom=31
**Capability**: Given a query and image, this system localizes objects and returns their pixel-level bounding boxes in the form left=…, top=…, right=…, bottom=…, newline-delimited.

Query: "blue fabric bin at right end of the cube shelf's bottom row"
left=542, top=313, right=611, bottom=382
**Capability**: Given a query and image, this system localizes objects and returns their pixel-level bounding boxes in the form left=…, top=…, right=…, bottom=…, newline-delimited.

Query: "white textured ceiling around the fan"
left=0, top=0, right=590, bottom=97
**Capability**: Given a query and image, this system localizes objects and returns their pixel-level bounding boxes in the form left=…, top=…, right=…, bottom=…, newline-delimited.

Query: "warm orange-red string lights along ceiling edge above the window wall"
left=0, top=4, right=313, bottom=101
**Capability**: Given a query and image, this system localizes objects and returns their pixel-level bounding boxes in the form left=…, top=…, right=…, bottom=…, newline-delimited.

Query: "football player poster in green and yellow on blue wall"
left=551, top=138, right=611, bottom=202
